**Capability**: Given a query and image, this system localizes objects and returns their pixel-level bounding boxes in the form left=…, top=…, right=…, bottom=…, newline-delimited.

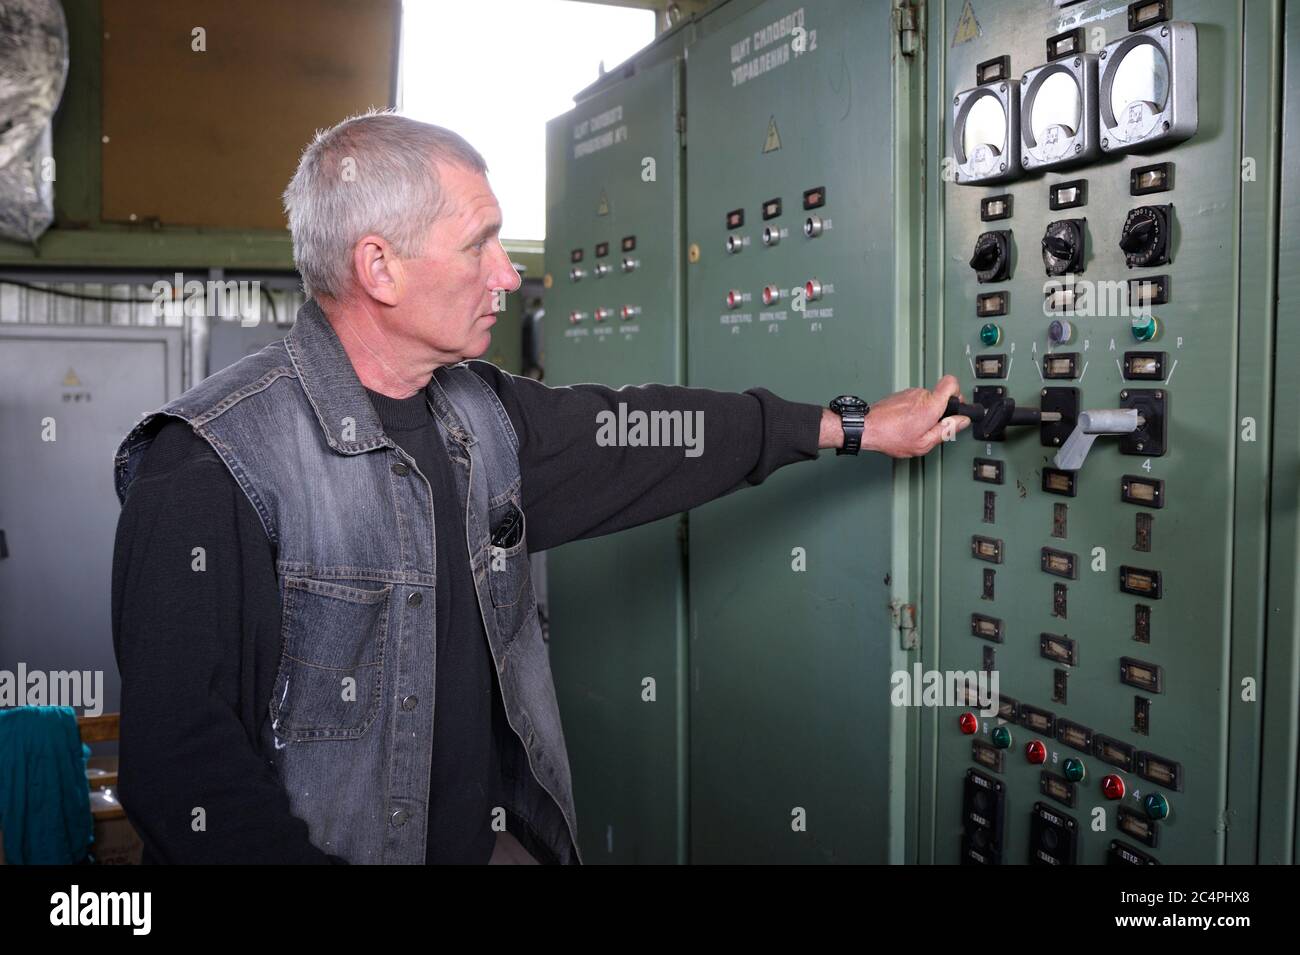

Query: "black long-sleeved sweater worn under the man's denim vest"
left=113, top=361, right=822, bottom=863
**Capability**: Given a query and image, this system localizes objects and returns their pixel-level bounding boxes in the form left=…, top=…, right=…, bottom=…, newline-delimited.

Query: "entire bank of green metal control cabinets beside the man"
left=546, top=0, right=1300, bottom=865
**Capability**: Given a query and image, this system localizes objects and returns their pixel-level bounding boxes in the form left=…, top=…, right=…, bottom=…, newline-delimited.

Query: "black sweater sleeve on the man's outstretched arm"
left=469, top=361, right=822, bottom=551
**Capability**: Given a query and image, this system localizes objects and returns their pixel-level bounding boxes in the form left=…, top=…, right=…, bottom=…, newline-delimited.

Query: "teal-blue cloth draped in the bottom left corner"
left=0, top=707, right=95, bottom=865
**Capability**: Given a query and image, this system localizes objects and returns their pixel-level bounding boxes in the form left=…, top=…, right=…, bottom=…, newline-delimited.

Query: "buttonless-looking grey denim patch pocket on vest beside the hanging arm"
left=270, top=577, right=393, bottom=741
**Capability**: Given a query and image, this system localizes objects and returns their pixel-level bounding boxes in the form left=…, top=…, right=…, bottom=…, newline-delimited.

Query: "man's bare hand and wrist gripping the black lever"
left=822, top=374, right=971, bottom=457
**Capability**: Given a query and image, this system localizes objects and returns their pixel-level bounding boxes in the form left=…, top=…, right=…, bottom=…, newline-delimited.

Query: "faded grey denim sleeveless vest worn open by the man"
left=114, top=300, right=581, bottom=863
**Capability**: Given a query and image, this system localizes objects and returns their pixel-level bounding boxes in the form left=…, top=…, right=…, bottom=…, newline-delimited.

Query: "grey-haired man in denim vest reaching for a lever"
left=113, top=113, right=969, bottom=863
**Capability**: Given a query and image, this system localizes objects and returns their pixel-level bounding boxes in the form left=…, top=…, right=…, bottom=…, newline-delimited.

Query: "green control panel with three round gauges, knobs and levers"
left=922, top=0, right=1271, bottom=865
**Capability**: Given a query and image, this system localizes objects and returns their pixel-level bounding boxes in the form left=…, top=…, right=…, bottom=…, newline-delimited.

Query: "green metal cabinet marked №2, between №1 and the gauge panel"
left=685, top=1, right=920, bottom=863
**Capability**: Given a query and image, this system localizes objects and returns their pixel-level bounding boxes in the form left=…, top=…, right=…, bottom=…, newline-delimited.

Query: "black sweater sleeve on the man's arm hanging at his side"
left=113, top=421, right=342, bottom=863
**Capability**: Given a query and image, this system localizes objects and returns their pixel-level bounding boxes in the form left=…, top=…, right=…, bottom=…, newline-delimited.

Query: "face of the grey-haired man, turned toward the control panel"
left=393, top=164, right=520, bottom=364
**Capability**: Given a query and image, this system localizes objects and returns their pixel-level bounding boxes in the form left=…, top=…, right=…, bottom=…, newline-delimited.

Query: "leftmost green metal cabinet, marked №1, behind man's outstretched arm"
left=543, top=48, right=686, bottom=863
